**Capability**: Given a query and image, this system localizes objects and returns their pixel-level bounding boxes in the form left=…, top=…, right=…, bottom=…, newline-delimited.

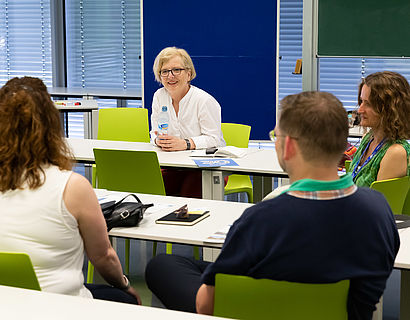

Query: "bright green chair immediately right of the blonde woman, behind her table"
left=221, top=123, right=253, bottom=203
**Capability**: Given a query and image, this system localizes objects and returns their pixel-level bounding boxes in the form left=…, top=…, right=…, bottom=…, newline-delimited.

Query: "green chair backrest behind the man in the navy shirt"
left=214, top=274, right=349, bottom=320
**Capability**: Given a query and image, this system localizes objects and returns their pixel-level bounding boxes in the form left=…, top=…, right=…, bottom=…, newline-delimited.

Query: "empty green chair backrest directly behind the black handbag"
left=94, top=149, right=165, bottom=195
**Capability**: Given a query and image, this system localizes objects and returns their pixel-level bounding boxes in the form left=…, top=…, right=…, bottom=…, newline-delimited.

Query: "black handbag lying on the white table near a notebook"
left=101, top=194, right=154, bottom=231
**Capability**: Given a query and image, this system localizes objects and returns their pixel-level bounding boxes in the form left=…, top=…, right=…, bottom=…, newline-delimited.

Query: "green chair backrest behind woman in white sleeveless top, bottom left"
left=0, top=252, right=41, bottom=291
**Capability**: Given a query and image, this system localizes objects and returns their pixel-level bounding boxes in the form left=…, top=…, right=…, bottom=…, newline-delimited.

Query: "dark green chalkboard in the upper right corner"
left=318, top=0, right=410, bottom=57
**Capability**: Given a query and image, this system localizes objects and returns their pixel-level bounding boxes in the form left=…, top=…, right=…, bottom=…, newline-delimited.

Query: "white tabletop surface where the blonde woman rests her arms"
left=67, top=138, right=287, bottom=177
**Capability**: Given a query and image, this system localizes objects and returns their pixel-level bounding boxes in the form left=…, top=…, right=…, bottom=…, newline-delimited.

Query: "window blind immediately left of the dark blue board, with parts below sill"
left=66, top=0, right=141, bottom=136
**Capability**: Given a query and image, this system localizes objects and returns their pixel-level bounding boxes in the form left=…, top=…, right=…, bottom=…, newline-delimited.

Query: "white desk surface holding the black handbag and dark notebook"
left=100, top=189, right=252, bottom=248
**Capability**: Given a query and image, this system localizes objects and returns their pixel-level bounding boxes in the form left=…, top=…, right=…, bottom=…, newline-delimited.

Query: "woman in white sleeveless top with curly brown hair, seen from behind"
left=0, top=77, right=140, bottom=304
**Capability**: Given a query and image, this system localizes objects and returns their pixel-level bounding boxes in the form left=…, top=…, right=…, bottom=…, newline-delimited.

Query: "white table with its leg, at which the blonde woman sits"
left=67, top=138, right=287, bottom=202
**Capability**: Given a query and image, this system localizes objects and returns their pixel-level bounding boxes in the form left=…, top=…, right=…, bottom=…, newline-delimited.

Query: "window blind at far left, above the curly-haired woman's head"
left=0, top=0, right=52, bottom=86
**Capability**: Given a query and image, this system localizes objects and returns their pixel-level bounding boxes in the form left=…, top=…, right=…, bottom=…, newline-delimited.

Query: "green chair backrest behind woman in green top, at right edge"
left=370, top=177, right=410, bottom=214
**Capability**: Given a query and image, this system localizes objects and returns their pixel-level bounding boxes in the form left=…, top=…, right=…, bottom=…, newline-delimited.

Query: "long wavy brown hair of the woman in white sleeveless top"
left=0, top=77, right=72, bottom=192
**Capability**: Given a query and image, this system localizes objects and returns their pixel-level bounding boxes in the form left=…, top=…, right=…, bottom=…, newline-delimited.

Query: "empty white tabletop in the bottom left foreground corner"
left=0, top=286, right=226, bottom=320
